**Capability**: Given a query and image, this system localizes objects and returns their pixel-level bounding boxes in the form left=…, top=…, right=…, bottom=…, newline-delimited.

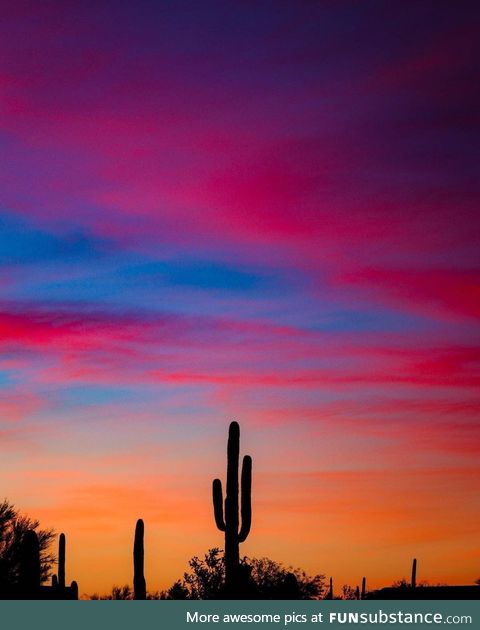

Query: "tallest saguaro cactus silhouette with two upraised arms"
left=212, top=422, right=252, bottom=596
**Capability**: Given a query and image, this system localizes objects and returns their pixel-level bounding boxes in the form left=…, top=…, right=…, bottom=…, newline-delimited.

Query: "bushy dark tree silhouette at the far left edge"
left=0, top=499, right=56, bottom=588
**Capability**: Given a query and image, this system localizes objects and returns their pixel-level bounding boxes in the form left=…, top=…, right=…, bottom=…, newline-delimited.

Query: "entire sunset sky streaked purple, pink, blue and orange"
left=0, top=0, right=480, bottom=593
